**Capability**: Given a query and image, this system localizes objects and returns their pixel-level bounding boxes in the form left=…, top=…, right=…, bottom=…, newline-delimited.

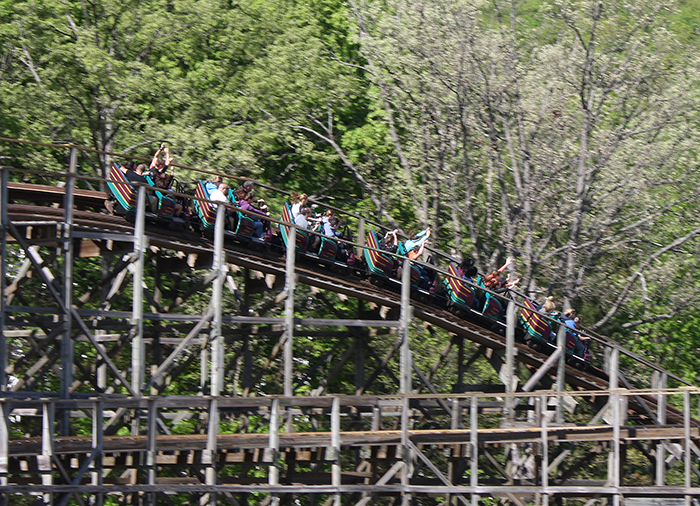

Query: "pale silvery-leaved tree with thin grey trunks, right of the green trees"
left=356, top=0, right=700, bottom=328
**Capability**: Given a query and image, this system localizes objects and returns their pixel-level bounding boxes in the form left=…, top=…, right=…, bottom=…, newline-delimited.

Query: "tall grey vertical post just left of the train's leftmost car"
left=60, top=148, right=78, bottom=436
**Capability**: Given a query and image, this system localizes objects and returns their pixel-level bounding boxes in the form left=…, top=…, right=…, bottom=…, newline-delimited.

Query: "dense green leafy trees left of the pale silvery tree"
left=0, top=0, right=378, bottom=204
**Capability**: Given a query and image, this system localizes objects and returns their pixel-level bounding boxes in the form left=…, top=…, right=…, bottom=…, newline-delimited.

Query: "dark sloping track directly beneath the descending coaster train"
left=8, top=200, right=682, bottom=422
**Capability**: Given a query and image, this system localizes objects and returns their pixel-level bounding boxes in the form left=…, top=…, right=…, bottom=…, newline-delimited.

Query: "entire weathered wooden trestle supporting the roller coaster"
left=0, top=139, right=700, bottom=506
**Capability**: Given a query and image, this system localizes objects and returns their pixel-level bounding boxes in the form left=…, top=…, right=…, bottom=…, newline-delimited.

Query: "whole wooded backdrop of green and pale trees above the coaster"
left=0, top=0, right=700, bottom=384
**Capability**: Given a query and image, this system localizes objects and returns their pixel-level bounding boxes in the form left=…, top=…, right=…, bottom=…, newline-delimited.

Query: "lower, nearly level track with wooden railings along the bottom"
left=0, top=388, right=700, bottom=502
